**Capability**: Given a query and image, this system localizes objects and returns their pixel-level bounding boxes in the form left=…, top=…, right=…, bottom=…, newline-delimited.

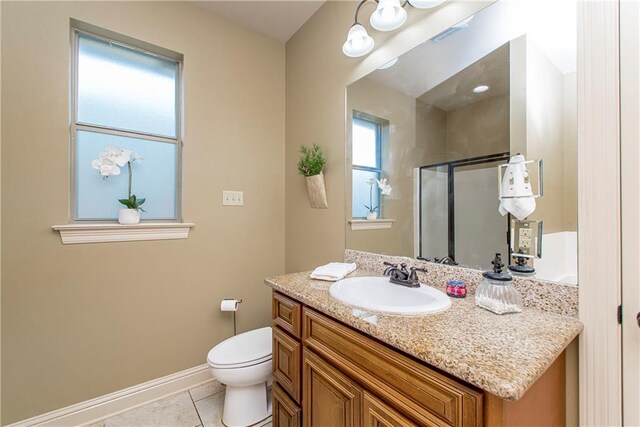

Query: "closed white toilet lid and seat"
left=207, top=326, right=272, bottom=369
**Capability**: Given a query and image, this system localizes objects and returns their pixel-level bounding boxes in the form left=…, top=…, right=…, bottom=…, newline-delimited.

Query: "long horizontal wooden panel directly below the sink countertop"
left=303, top=307, right=483, bottom=426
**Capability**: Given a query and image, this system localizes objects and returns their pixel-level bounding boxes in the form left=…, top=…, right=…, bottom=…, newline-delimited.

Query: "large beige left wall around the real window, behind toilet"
left=2, top=2, right=284, bottom=423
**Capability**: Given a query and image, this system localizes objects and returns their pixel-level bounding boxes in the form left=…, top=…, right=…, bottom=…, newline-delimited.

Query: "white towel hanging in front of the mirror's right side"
left=498, top=155, right=536, bottom=220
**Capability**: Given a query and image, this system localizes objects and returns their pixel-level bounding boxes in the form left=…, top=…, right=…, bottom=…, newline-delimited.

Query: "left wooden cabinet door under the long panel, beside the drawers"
left=302, top=349, right=362, bottom=427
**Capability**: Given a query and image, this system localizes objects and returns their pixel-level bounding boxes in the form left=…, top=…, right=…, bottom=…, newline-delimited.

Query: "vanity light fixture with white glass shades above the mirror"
left=342, top=0, right=446, bottom=58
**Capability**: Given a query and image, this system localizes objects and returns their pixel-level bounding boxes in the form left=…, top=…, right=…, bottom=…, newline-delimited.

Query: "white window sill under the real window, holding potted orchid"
left=51, top=222, right=195, bottom=245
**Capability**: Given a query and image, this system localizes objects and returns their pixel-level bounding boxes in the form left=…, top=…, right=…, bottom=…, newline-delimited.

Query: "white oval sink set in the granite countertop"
left=329, top=277, right=451, bottom=314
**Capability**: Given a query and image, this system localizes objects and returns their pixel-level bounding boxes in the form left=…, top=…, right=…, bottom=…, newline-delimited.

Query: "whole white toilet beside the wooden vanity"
left=207, top=327, right=272, bottom=427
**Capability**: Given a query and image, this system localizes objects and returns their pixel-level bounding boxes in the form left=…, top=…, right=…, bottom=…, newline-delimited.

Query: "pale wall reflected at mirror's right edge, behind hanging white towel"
left=510, top=36, right=578, bottom=234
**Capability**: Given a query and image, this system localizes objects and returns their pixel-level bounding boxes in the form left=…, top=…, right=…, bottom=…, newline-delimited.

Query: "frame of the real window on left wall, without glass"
left=69, top=19, right=184, bottom=224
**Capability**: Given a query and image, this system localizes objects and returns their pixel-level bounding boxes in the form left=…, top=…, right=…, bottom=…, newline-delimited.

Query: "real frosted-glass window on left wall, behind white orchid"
left=71, top=21, right=182, bottom=221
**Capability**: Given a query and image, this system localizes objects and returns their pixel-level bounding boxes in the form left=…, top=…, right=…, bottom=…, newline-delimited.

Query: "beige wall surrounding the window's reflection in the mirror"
left=345, top=78, right=424, bottom=257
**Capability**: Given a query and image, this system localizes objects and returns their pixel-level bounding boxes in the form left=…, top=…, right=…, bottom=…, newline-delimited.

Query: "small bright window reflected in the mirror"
left=351, top=111, right=386, bottom=218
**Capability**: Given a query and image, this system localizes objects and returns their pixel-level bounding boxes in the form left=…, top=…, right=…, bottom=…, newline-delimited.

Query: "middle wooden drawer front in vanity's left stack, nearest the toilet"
left=273, top=326, right=302, bottom=403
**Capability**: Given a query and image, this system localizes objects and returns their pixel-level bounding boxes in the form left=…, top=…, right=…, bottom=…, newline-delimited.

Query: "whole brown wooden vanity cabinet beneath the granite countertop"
left=273, top=292, right=564, bottom=427
